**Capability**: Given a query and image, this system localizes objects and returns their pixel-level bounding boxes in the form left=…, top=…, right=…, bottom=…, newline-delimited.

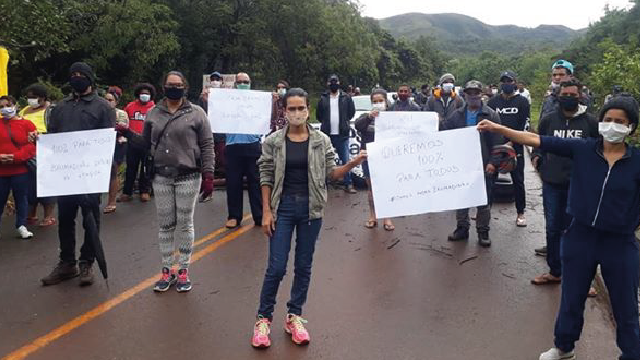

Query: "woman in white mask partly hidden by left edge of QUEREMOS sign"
left=356, top=89, right=395, bottom=231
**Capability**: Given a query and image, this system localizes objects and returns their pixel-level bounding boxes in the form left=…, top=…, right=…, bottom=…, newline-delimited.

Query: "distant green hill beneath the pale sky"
left=379, top=13, right=584, bottom=56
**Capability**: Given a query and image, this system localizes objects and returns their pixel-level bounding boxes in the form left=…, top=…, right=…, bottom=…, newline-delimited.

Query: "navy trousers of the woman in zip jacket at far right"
left=554, top=220, right=640, bottom=360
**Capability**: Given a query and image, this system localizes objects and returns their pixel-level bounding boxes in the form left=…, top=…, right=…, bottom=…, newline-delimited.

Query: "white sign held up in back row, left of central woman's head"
left=209, top=89, right=272, bottom=135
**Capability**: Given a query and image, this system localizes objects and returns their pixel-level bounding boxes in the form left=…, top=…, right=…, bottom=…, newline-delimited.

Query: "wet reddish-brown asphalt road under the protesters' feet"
left=0, top=160, right=619, bottom=360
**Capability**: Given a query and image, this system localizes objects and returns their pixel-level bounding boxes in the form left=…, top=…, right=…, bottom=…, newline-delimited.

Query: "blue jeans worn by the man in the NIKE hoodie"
left=542, top=182, right=571, bottom=277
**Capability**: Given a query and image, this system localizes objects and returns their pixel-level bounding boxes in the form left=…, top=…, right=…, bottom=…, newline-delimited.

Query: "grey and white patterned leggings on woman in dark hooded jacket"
left=153, top=173, right=202, bottom=269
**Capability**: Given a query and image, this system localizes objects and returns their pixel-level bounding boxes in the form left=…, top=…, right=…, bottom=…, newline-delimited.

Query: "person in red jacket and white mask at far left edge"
left=0, top=96, right=36, bottom=239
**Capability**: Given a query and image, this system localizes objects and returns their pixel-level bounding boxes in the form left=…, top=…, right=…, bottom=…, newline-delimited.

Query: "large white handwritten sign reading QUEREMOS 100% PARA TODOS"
left=367, top=128, right=487, bottom=218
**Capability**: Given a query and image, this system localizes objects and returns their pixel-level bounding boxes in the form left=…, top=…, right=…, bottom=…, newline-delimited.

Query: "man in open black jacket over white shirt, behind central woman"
left=316, top=75, right=356, bottom=194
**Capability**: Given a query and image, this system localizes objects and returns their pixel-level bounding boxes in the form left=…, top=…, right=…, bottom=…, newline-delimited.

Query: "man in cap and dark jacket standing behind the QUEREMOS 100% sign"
left=441, top=80, right=504, bottom=247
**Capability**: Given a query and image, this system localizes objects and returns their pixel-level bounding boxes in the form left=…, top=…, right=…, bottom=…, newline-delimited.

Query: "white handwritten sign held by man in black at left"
left=36, top=129, right=116, bottom=197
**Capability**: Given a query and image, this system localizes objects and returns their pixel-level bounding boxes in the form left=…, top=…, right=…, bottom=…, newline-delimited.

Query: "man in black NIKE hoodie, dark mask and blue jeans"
left=531, top=80, right=599, bottom=285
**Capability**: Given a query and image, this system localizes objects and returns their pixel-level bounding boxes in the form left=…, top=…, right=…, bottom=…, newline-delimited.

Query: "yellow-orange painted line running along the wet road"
left=2, top=224, right=254, bottom=360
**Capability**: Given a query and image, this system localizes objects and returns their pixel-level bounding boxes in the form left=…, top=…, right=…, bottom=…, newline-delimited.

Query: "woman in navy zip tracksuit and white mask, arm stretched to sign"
left=478, top=96, right=640, bottom=360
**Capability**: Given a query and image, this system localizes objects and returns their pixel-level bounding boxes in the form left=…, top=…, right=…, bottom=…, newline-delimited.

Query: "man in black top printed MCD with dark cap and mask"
left=487, top=71, right=531, bottom=227
